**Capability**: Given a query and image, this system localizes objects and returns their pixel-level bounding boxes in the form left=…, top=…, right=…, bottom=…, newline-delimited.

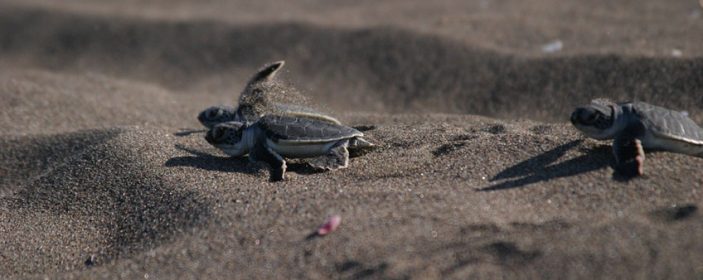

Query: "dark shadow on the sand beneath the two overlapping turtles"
left=164, top=144, right=324, bottom=177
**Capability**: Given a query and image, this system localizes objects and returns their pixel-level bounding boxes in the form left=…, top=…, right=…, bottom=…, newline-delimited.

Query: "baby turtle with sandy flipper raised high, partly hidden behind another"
left=198, top=61, right=340, bottom=128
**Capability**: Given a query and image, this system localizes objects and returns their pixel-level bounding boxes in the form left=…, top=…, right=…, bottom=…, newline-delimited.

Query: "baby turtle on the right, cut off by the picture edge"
left=571, top=99, right=703, bottom=176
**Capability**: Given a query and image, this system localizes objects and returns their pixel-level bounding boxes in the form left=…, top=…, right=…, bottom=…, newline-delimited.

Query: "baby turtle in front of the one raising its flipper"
left=205, top=115, right=374, bottom=181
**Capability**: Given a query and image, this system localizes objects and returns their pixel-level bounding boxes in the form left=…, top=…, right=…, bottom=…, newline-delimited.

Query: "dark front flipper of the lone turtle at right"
left=613, top=123, right=645, bottom=178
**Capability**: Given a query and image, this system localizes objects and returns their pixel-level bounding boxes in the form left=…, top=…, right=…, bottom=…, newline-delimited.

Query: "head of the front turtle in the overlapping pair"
left=205, top=121, right=249, bottom=157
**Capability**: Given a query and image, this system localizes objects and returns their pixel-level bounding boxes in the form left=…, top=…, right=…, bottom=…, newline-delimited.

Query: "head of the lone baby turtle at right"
left=571, top=99, right=620, bottom=140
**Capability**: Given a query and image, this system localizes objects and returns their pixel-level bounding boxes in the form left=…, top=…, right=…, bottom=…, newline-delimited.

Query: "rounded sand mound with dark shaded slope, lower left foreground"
left=0, top=128, right=209, bottom=275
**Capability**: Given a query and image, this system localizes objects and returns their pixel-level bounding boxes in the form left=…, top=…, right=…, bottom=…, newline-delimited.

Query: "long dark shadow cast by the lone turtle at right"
left=478, top=139, right=619, bottom=191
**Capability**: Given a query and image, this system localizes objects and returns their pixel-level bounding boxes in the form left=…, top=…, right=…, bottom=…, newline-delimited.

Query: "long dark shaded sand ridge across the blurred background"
left=0, top=4, right=703, bottom=121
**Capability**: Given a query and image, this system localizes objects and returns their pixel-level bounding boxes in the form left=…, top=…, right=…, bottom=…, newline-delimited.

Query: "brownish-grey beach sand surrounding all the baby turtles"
left=0, top=0, right=703, bottom=279
